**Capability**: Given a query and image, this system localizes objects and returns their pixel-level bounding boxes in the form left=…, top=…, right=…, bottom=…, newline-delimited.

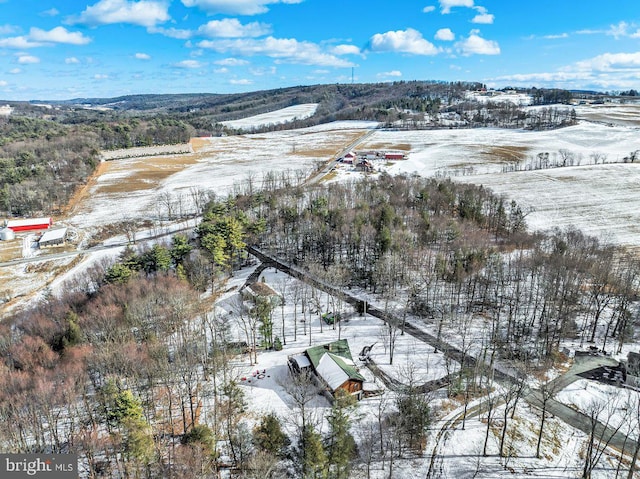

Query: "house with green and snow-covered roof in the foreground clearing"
left=289, top=339, right=365, bottom=399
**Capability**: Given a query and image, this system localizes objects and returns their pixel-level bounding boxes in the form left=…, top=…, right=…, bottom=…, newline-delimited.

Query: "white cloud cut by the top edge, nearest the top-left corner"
left=69, top=0, right=171, bottom=27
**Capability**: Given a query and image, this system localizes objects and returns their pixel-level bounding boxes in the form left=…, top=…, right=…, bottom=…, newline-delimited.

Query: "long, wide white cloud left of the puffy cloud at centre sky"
left=198, top=36, right=353, bottom=67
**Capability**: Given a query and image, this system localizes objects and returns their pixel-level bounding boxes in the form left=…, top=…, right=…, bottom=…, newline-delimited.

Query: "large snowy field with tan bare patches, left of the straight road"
left=69, top=122, right=375, bottom=232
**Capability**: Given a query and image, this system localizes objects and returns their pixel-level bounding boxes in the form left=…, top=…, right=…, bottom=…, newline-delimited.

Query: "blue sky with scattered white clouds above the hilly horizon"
left=0, top=0, right=640, bottom=100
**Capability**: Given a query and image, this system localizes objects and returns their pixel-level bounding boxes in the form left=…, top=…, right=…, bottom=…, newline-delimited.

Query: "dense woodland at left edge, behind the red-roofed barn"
left=0, top=112, right=195, bottom=216
